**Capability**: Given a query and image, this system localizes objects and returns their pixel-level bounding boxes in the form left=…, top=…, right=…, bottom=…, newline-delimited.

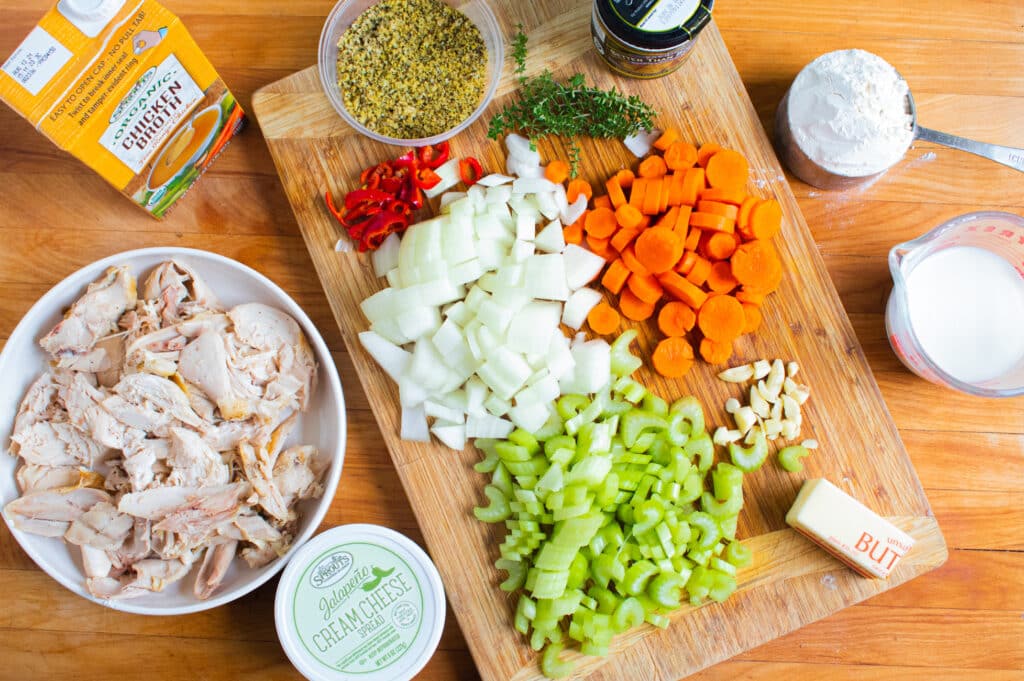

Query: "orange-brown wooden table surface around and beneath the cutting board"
left=0, top=0, right=1024, bottom=681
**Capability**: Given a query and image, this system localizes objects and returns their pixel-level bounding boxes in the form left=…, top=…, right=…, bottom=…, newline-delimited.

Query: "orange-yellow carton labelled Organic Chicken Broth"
left=0, top=0, right=245, bottom=218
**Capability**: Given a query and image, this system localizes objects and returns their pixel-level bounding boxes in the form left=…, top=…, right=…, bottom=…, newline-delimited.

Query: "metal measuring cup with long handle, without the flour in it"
left=775, top=67, right=1024, bottom=189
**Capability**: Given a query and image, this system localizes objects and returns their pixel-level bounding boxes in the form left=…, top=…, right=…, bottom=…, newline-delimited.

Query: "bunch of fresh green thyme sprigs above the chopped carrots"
left=487, top=24, right=657, bottom=177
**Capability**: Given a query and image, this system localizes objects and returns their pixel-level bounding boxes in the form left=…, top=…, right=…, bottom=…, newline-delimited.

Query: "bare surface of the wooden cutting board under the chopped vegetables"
left=253, top=0, right=946, bottom=681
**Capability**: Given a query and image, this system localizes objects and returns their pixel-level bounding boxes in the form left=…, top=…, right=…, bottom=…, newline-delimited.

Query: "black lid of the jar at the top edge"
left=595, top=0, right=715, bottom=50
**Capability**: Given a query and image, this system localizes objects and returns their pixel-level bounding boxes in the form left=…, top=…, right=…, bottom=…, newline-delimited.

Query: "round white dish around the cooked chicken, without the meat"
left=0, top=248, right=345, bottom=614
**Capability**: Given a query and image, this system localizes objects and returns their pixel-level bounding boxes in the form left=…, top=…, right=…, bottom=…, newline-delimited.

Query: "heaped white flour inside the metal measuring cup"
left=788, top=49, right=913, bottom=177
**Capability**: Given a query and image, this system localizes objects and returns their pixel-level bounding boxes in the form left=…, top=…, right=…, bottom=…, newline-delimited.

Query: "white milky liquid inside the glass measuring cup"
left=906, top=246, right=1024, bottom=383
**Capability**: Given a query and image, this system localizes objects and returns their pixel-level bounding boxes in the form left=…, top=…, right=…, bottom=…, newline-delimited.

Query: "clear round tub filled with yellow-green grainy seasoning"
left=319, top=0, right=504, bottom=146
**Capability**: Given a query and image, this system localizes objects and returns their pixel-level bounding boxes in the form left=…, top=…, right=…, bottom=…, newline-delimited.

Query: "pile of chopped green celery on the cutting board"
left=474, top=331, right=758, bottom=677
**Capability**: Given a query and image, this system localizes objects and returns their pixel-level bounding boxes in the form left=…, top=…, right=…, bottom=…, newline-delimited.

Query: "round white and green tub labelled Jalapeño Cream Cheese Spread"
left=273, top=524, right=444, bottom=681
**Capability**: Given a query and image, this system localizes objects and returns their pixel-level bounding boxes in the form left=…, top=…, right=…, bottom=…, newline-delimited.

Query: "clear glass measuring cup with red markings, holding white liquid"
left=886, top=211, right=1024, bottom=397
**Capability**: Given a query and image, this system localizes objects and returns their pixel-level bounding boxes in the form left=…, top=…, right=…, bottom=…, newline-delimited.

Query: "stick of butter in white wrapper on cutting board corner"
left=785, top=478, right=913, bottom=580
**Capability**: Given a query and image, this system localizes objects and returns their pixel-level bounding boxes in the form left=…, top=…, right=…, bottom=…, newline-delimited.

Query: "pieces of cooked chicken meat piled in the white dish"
left=3, top=260, right=330, bottom=599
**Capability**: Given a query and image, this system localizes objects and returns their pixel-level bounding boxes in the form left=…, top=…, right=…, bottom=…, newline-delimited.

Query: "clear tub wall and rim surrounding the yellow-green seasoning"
left=317, top=0, right=505, bottom=146
